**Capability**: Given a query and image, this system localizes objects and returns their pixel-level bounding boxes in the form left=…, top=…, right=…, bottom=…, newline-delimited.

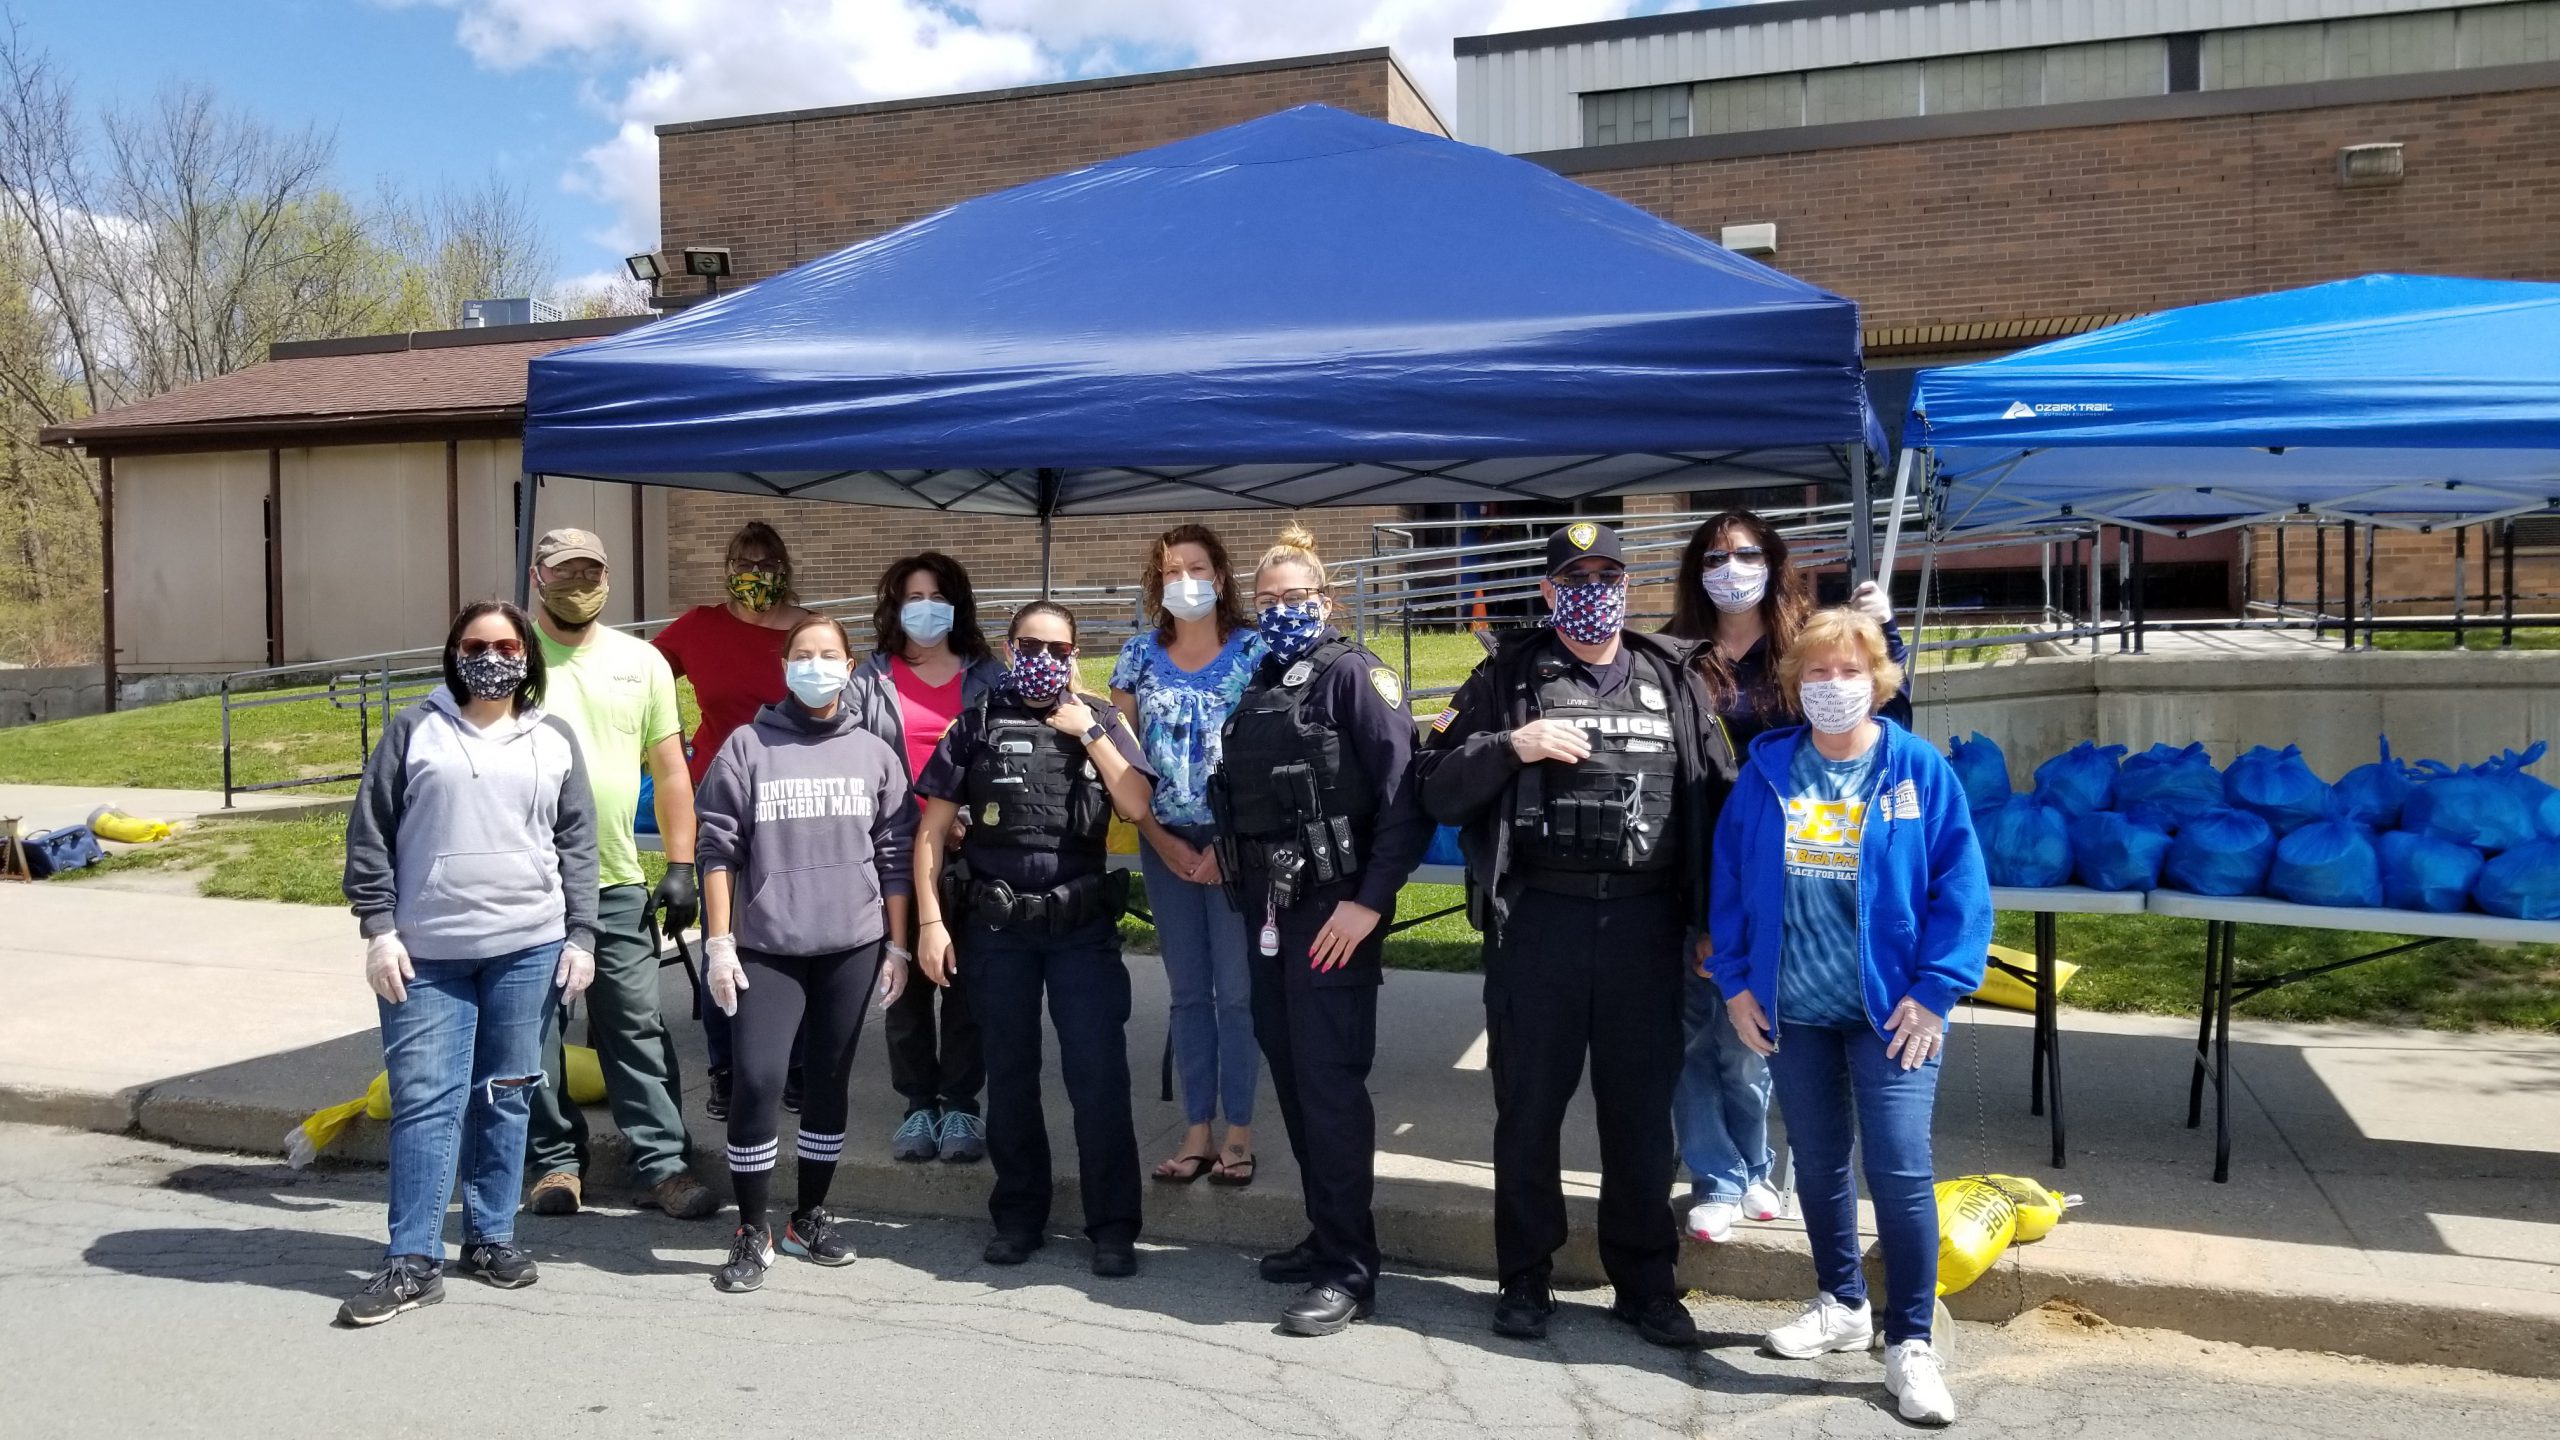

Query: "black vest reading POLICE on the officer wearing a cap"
left=1510, top=656, right=1679, bottom=874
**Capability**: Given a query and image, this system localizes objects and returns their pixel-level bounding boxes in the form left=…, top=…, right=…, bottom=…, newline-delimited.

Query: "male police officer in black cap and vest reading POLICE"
left=1416, top=523, right=1736, bottom=1348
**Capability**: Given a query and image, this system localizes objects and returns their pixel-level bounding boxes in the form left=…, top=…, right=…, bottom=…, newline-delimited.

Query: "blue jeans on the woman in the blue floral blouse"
left=1139, top=825, right=1262, bottom=1125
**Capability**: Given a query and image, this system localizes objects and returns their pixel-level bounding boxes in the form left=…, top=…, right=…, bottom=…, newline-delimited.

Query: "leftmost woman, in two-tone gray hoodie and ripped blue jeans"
left=338, top=602, right=596, bottom=1325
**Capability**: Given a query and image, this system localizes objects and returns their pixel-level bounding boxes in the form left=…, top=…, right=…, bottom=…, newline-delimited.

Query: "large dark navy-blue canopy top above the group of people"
left=522, top=105, right=1884, bottom=589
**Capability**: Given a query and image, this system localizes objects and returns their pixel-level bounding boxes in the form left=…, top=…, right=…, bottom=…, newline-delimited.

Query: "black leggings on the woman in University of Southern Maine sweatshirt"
left=730, top=940, right=881, bottom=1225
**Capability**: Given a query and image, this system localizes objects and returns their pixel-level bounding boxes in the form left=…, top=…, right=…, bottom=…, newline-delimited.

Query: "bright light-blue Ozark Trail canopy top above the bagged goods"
left=1902, top=274, right=2560, bottom=536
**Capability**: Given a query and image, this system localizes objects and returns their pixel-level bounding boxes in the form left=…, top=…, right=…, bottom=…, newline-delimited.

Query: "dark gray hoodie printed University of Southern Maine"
left=694, top=700, right=916, bottom=956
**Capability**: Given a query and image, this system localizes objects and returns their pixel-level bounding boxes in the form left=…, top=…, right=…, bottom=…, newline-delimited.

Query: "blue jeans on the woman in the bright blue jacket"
left=1769, top=1022, right=1938, bottom=1343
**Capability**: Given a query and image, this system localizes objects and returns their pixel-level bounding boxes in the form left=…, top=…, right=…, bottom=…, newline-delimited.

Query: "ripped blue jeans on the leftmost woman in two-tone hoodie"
left=374, top=940, right=561, bottom=1261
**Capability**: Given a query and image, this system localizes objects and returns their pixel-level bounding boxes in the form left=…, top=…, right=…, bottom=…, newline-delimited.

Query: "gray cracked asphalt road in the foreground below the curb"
left=0, top=1125, right=2560, bottom=1440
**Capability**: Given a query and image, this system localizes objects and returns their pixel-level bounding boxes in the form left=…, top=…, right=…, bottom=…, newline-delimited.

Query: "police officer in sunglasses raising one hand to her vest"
left=916, top=600, right=1155, bottom=1276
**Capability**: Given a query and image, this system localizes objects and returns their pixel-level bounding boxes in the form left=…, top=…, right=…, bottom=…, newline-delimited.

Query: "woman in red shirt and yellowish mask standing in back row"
left=650, top=520, right=812, bottom=1120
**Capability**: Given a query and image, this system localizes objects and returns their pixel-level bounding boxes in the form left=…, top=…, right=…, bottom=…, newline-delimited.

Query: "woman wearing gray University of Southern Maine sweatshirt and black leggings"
left=694, top=615, right=916, bottom=1291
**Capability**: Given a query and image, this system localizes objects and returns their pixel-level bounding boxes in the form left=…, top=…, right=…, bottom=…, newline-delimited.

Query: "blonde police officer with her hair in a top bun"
left=1208, top=525, right=1431, bottom=1335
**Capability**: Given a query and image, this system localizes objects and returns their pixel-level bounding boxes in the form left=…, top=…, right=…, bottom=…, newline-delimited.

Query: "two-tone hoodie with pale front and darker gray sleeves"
left=343, top=687, right=596, bottom=961
